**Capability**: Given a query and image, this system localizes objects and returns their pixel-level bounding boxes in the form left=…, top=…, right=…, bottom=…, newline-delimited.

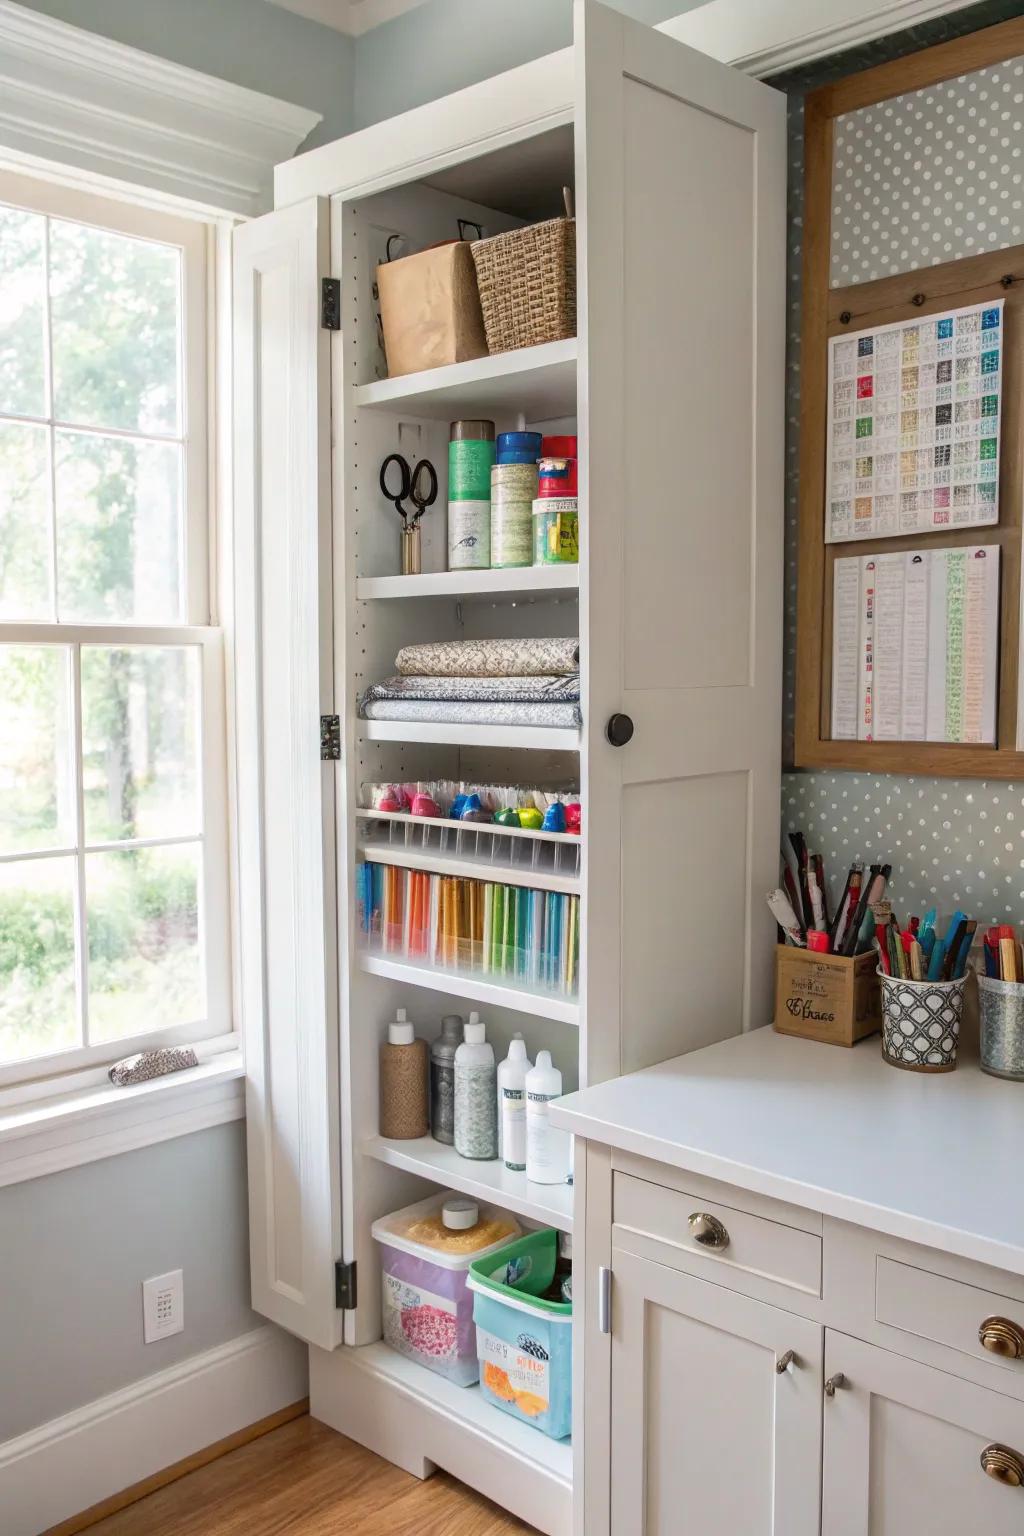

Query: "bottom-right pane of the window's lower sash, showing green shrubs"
left=86, top=843, right=206, bottom=1041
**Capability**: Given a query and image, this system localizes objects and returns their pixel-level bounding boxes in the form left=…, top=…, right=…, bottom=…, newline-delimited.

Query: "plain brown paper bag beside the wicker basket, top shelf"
left=378, top=240, right=487, bottom=378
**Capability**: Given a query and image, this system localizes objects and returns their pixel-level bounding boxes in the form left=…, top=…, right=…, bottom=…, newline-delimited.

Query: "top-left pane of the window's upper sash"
left=0, top=207, right=46, bottom=416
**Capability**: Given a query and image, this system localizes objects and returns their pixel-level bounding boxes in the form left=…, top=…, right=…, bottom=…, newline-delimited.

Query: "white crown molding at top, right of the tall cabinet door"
left=659, top=0, right=964, bottom=80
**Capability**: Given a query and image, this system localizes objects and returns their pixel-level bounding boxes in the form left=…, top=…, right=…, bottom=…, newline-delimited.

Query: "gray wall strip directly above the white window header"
left=11, top=0, right=355, bottom=149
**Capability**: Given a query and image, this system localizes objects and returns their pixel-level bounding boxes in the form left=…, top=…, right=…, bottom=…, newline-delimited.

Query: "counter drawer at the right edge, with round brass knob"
left=875, top=1253, right=1024, bottom=1390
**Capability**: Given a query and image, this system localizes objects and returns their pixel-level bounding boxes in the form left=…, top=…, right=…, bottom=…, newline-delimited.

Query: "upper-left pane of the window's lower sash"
left=0, top=645, right=75, bottom=854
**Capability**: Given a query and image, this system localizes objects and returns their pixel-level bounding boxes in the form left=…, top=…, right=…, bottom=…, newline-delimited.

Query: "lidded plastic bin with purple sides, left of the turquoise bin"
left=372, top=1193, right=520, bottom=1387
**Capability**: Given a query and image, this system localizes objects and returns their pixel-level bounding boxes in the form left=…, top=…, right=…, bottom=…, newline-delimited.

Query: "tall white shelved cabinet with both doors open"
left=235, top=0, right=786, bottom=1533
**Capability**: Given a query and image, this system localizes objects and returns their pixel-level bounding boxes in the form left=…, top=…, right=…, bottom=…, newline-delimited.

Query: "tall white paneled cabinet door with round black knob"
left=576, top=0, right=786, bottom=1081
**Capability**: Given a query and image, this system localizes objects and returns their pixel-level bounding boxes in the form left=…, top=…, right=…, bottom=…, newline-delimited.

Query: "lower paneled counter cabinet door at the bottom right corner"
left=821, top=1330, right=1024, bottom=1536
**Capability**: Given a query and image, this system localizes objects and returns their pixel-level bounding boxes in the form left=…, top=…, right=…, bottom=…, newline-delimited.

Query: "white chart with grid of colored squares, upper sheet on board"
left=826, top=300, right=1003, bottom=544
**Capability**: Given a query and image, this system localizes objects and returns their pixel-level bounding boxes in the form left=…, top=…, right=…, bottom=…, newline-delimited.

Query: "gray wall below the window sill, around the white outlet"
left=0, top=1121, right=263, bottom=1443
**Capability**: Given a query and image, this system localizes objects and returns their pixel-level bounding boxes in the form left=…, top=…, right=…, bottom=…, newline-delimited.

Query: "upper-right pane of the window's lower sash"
left=81, top=645, right=200, bottom=843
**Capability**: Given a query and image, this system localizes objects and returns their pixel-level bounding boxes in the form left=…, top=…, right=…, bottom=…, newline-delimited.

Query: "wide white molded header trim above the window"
left=0, top=0, right=321, bottom=215
